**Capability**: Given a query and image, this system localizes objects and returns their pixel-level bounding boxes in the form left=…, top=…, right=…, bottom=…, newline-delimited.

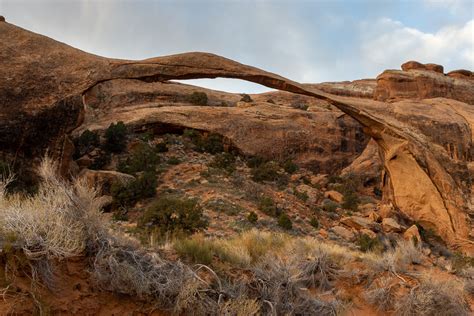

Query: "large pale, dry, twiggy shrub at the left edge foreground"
left=0, top=158, right=107, bottom=287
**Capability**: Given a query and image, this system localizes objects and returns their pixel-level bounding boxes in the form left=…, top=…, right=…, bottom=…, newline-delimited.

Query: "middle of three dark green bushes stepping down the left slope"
left=118, top=143, right=160, bottom=174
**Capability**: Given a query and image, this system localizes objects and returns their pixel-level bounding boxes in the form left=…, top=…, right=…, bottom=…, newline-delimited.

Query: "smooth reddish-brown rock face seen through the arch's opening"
left=74, top=79, right=368, bottom=173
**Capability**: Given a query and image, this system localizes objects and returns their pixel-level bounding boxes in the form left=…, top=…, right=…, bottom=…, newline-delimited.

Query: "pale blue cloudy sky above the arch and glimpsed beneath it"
left=0, top=0, right=474, bottom=93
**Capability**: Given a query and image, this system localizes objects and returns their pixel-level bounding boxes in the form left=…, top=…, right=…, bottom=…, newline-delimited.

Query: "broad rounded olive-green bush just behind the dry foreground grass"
left=140, top=195, right=208, bottom=233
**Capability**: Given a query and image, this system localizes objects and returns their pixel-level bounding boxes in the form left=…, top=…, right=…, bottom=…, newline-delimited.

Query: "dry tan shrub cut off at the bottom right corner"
left=395, top=279, right=471, bottom=316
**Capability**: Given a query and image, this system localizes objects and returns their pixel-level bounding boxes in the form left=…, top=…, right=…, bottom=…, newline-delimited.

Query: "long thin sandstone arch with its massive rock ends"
left=0, top=23, right=474, bottom=252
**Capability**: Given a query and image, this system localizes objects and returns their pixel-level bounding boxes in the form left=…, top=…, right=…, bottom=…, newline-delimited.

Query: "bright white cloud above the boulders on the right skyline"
left=360, top=18, right=474, bottom=71
